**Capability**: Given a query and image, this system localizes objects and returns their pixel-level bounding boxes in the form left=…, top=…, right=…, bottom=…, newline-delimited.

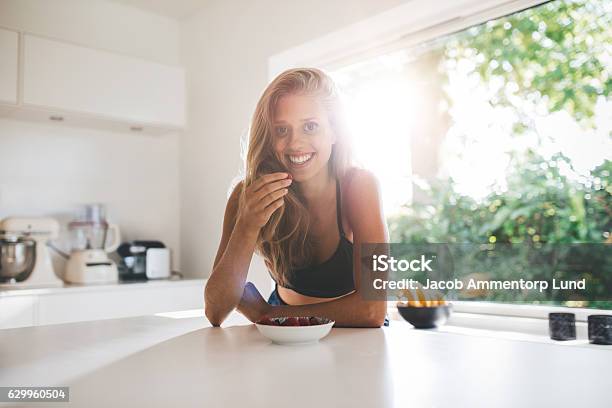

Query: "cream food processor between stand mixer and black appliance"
left=64, top=204, right=121, bottom=284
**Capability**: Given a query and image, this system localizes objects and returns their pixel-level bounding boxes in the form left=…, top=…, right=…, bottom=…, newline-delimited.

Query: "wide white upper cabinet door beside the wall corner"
left=23, top=34, right=185, bottom=128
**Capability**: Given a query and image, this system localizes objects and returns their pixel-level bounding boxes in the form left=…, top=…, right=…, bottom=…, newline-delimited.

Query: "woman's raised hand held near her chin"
left=237, top=173, right=292, bottom=231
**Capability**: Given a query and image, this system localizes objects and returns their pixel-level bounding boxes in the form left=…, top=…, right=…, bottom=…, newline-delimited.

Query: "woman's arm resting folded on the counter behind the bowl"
left=238, top=169, right=389, bottom=327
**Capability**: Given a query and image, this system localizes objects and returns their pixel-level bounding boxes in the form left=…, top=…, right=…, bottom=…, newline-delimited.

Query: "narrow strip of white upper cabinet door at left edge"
left=0, top=28, right=19, bottom=105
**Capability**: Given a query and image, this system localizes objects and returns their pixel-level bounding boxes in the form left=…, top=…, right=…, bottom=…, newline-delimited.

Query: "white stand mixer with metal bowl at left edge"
left=0, top=217, right=63, bottom=287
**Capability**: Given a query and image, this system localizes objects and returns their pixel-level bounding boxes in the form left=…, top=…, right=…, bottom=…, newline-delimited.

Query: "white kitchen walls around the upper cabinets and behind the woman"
left=0, top=0, right=410, bottom=287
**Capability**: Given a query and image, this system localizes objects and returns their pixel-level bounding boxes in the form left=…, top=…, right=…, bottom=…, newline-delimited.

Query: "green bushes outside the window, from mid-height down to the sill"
left=388, top=151, right=612, bottom=308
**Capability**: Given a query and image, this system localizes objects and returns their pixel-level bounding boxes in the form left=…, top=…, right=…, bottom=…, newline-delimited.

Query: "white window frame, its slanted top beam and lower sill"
left=268, top=0, right=611, bottom=322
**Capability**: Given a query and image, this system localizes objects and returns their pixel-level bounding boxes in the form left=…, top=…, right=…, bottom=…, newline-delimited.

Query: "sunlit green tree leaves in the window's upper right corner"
left=446, top=0, right=612, bottom=126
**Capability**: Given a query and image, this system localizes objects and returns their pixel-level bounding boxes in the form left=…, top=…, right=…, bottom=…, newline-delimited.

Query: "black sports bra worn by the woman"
left=277, top=179, right=355, bottom=298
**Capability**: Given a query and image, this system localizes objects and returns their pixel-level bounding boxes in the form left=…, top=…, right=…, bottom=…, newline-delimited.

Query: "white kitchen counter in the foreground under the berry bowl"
left=0, top=310, right=612, bottom=407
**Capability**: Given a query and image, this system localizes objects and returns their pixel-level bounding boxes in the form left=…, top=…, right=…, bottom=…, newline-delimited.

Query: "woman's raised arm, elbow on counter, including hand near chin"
left=204, top=173, right=290, bottom=326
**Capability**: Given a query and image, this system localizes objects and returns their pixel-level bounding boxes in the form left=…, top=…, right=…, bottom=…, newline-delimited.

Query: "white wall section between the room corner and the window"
left=180, top=0, right=409, bottom=292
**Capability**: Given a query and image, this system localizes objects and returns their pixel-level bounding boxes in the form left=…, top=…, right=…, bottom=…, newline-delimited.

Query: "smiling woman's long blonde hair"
left=240, top=68, right=351, bottom=285
